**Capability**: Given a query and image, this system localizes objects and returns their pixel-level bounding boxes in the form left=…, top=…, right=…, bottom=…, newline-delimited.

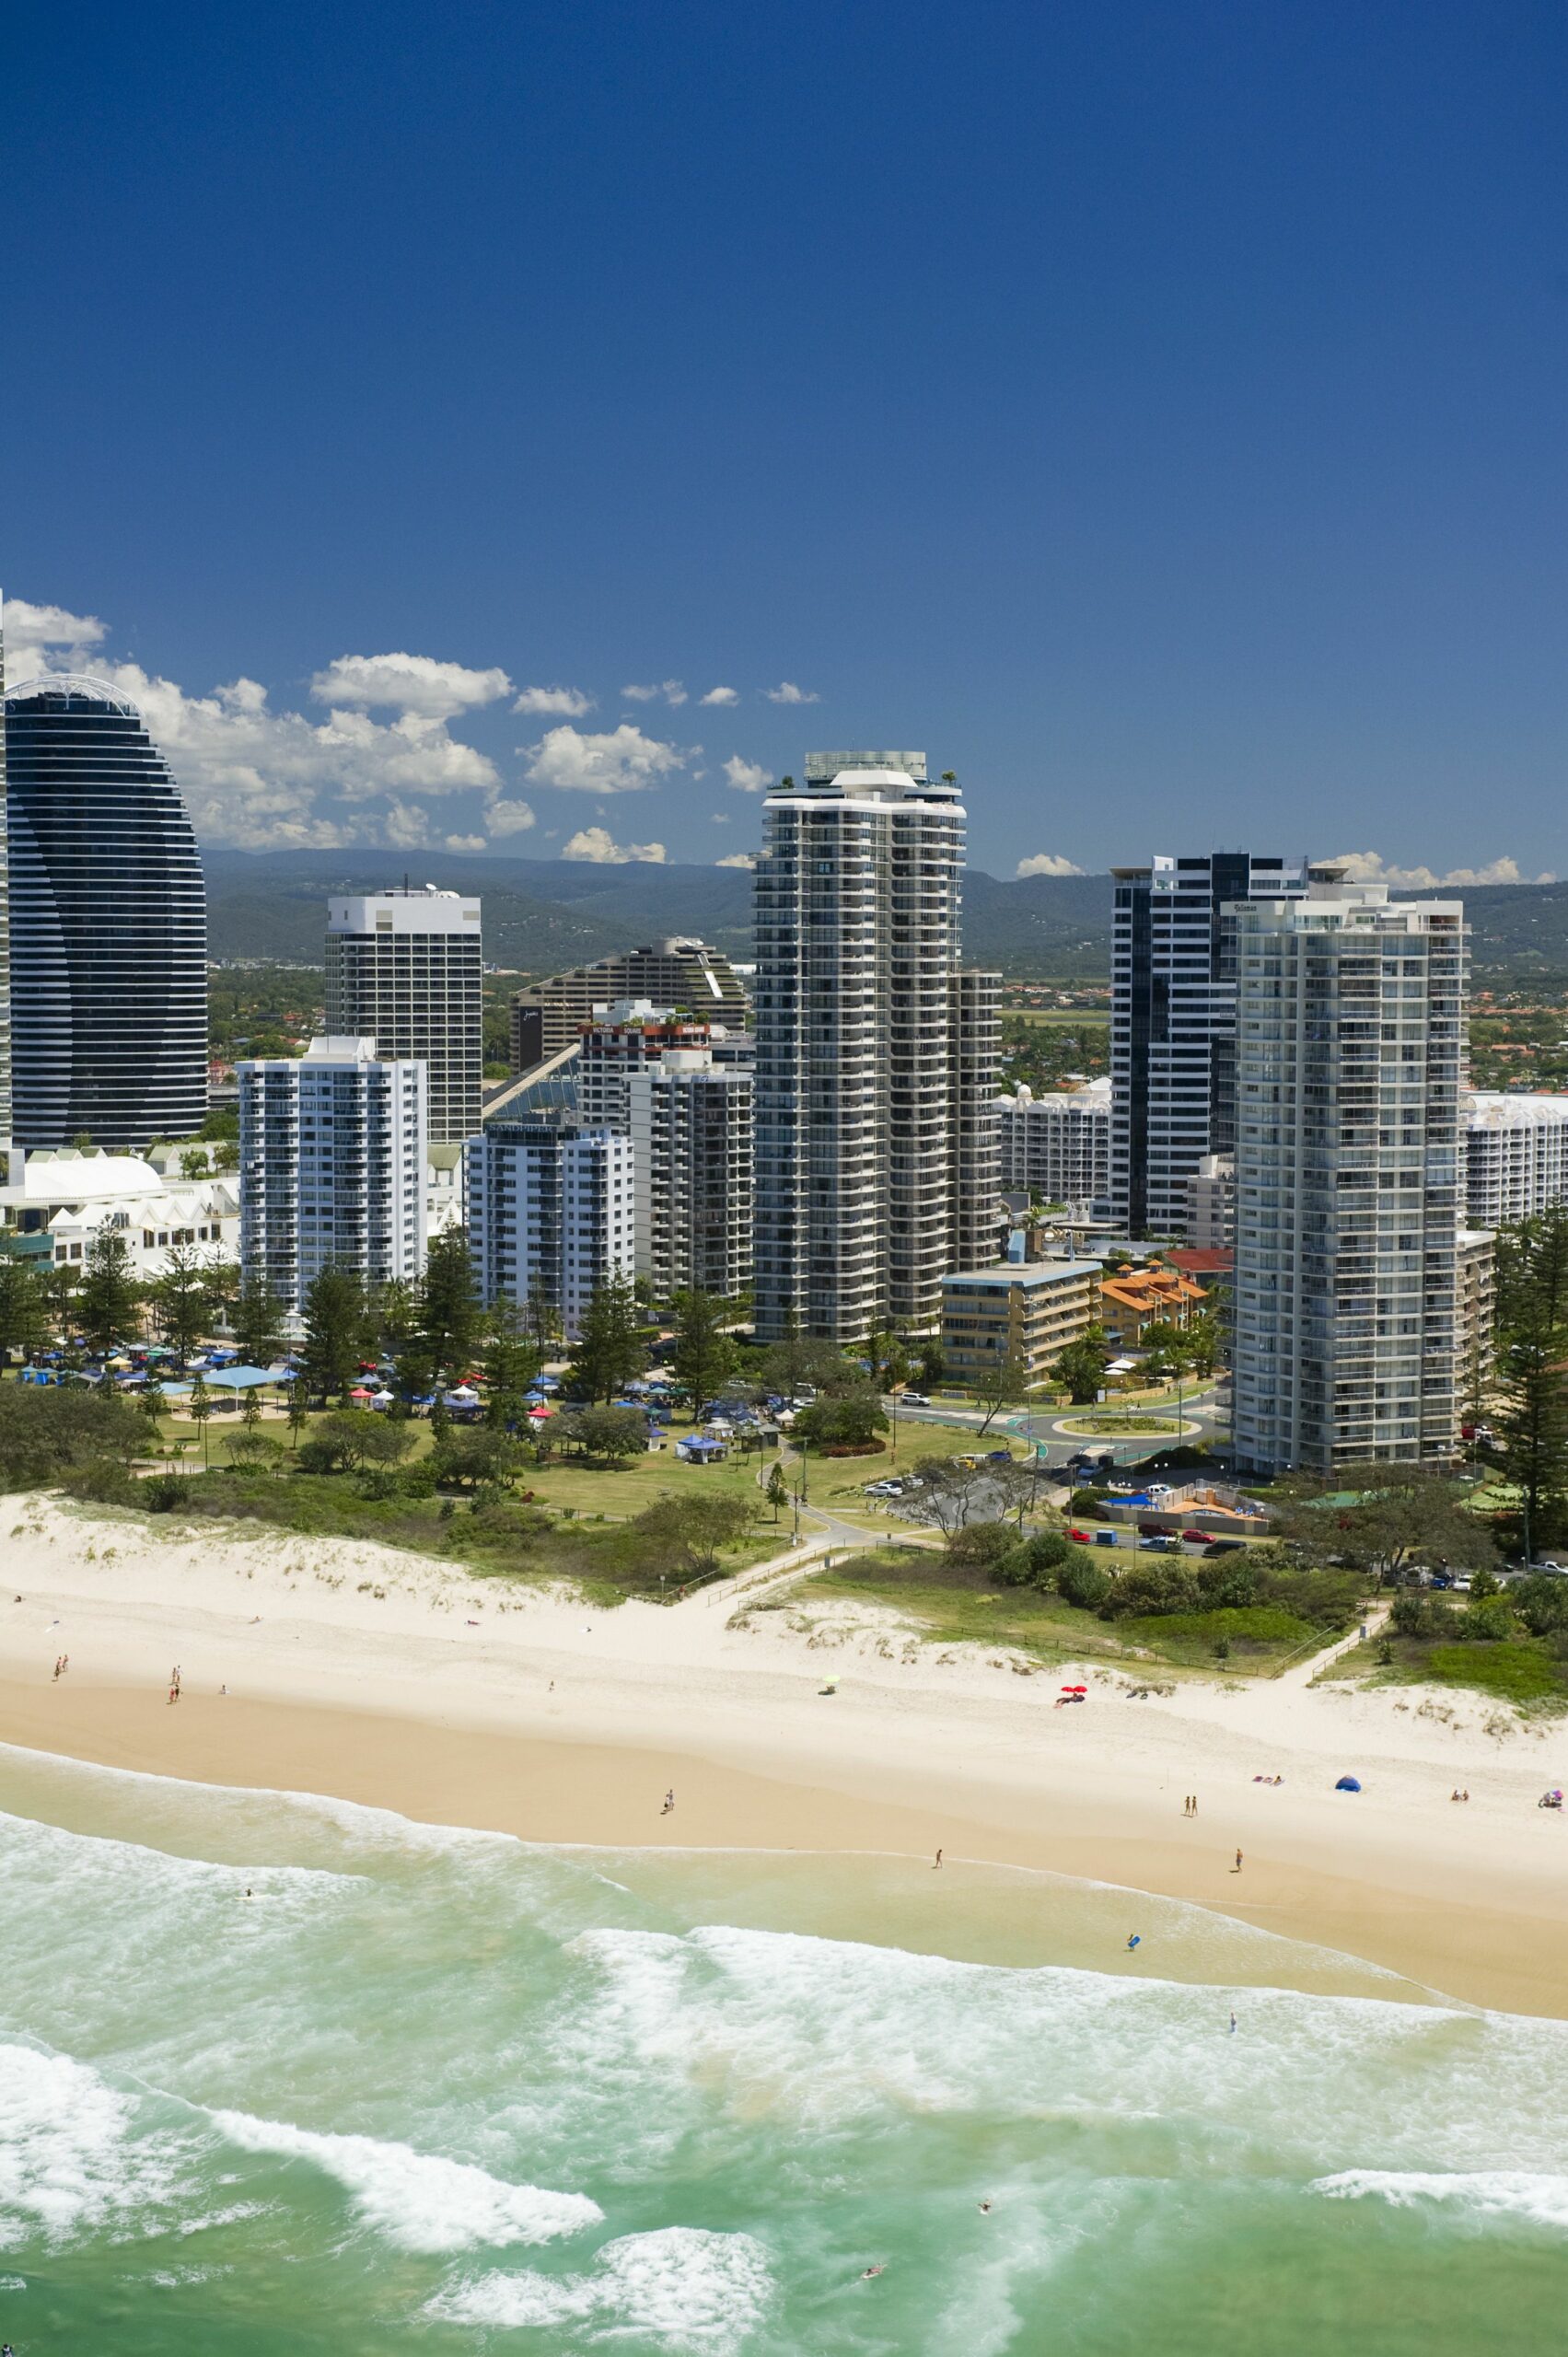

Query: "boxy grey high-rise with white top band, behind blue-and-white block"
left=328, top=884, right=483, bottom=1145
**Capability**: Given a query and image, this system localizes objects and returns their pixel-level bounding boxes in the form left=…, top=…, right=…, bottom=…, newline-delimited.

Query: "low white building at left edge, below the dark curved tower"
left=0, top=1145, right=240, bottom=1278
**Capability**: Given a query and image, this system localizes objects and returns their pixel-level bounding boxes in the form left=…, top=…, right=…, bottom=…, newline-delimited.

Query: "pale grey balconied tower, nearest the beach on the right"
left=1233, top=886, right=1467, bottom=1473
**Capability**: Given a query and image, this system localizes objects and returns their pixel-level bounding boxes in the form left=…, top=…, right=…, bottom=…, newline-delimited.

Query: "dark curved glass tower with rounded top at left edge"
left=5, top=679, right=207, bottom=1153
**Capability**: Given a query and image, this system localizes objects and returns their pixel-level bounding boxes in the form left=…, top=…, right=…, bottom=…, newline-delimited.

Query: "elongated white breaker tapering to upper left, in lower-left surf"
left=212, top=2112, right=604, bottom=2251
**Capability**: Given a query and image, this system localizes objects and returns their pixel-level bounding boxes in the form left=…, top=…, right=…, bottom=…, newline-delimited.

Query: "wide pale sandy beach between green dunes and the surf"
left=0, top=1497, right=1568, bottom=2015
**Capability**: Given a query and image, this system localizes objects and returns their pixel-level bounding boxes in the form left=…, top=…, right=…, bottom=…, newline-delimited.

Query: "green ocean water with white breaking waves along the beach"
left=0, top=1751, right=1568, bottom=2357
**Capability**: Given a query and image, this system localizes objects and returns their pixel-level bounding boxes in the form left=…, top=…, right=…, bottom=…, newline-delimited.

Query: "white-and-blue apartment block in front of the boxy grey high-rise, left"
left=236, top=1035, right=427, bottom=1313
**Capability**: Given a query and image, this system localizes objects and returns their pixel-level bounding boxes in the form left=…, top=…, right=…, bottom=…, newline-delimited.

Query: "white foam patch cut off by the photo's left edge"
left=0, top=2046, right=175, bottom=2248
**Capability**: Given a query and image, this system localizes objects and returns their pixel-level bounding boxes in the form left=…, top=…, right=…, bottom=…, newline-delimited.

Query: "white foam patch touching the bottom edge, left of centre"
left=427, top=2225, right=773, bottom=2357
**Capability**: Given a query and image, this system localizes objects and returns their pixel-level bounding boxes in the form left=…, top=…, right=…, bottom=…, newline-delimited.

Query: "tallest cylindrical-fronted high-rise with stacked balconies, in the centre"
left=754, top=752, right=1000, bottom=1341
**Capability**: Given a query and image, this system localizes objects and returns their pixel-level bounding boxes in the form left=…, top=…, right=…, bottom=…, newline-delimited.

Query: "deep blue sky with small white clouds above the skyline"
left=0, top=0, right=1568, bottom=875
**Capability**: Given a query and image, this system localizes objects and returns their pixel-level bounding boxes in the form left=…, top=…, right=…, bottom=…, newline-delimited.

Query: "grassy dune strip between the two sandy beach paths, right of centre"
left=790, top=1546, right=1334, bottom=1678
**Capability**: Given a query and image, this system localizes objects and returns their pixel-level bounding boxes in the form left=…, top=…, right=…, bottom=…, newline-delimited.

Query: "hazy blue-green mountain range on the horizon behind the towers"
left=203, top=851, right=1568, bottom=981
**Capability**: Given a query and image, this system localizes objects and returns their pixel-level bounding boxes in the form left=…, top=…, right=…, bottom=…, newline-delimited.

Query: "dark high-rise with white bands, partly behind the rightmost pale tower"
left=1110, top=851, right=1307, bottom=1237
